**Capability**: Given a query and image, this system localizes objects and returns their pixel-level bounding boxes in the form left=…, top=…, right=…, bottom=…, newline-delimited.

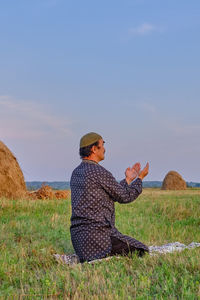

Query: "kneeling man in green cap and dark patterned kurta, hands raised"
left=70, top=132, right=149, bottom=262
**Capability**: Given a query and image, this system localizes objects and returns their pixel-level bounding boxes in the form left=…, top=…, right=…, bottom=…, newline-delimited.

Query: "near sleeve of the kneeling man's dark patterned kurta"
left=99, top=169, right=142, bottom=203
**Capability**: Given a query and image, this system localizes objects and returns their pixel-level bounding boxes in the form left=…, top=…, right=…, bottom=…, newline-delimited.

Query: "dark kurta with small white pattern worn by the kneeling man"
left=70, top=160, right=148, bottom=262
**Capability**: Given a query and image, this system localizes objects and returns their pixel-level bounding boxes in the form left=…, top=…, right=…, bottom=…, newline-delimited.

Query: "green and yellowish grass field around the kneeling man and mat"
left=0, top=189, right=200, bottom=300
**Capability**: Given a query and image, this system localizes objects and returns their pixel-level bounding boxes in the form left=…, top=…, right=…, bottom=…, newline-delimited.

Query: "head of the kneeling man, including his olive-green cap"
left=79, top=132, right=105, bottom=162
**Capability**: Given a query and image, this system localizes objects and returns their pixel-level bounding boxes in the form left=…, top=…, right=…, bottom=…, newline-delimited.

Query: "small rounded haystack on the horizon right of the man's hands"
left=162, top=171, right=187, bottom=190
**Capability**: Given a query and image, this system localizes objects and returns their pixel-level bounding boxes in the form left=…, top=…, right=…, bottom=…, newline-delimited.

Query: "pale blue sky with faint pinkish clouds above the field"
left=0, top=0, right=200, bottom=182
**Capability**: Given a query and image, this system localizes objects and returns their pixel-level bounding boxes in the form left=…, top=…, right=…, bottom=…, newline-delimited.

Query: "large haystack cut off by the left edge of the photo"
left=0, top=141, right=26, bottom=199
